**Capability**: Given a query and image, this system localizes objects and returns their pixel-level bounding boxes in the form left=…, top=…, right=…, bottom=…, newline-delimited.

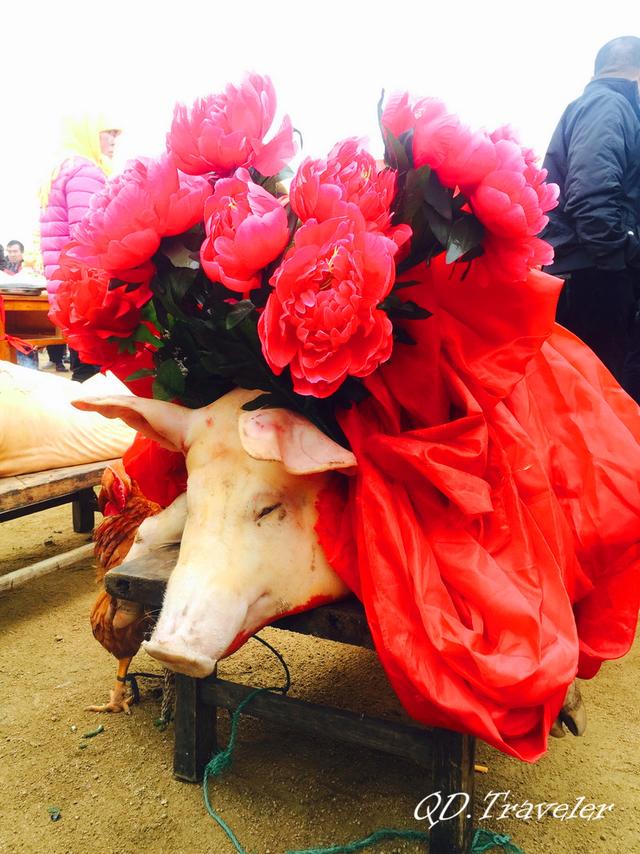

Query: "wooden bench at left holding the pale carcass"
left=0, top=460, right=116, bottom=534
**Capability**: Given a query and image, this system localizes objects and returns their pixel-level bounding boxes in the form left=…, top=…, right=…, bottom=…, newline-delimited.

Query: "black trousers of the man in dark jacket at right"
left=556, top=268, right=640, bottom=403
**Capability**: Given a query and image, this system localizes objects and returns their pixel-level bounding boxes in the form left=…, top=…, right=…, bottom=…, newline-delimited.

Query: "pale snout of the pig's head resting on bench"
left=143, top=591, right=247, bottom=679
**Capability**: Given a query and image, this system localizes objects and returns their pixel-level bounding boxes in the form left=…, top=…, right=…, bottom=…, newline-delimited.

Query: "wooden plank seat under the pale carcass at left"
left=0, top=460, right=116, bottom=513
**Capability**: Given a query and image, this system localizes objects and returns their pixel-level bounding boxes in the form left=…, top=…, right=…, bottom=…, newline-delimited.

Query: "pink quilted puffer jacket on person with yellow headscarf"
left=40, top=157, right=106, bottom=295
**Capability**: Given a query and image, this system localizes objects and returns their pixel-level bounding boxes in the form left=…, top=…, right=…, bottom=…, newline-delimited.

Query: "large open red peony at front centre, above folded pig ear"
left=258, top=211, right=397, bottom=397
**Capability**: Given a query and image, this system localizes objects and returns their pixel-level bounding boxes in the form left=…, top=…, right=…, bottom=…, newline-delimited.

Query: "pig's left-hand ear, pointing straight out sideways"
left=71, top=394, right=194, bottom=453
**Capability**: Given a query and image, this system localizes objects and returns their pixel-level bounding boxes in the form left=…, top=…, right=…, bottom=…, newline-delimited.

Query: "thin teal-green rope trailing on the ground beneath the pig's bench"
left=202, top=635, right=524, bottom=854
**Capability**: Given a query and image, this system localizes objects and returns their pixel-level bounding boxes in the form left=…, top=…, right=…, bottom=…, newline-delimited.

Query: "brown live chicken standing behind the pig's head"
left=87, top=464, right=162, bottom=714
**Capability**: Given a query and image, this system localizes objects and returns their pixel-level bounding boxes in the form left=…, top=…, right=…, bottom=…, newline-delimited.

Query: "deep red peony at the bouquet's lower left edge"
left=49, top=253, right=154, bottom=367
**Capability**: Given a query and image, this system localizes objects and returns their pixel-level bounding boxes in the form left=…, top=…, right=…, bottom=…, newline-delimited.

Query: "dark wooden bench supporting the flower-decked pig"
left=105, top=548, right=475, bottom=854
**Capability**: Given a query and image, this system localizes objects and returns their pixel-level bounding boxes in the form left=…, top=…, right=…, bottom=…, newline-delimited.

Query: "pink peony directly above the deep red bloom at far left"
left=72, top=154, right=211, bottom=272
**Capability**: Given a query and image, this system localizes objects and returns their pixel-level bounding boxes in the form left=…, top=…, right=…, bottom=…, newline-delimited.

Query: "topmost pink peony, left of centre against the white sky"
left=167, top=74, right=296, bottom=176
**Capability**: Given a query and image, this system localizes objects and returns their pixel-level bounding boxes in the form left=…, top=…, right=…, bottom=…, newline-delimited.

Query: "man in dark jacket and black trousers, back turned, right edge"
left=542, top=36, right=640, bottom=402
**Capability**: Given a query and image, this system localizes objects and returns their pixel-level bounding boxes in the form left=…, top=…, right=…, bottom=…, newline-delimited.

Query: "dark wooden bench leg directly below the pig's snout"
left=173, top=673, right=216, bottom=783
